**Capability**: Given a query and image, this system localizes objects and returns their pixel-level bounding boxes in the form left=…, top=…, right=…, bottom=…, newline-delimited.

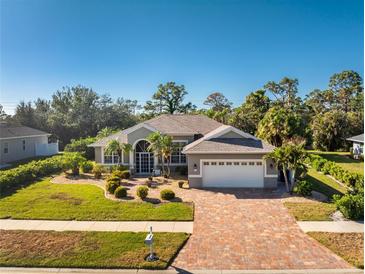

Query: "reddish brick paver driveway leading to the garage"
left=172, top=189, right=351, bottom=270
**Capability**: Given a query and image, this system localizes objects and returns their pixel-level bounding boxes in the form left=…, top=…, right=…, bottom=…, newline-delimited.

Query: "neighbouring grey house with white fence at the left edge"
left=0, top=123, right=58, bottom=164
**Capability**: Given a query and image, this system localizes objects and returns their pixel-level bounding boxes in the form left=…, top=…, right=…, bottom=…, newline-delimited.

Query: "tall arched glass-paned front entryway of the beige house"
left=134, top=140, right=154, bottom=174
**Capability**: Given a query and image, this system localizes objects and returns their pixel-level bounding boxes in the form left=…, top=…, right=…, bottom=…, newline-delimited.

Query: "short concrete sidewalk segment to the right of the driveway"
left=297, top=221, right=364, bottom=233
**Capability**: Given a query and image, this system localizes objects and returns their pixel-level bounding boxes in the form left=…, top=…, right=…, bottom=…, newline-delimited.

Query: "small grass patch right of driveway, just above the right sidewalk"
left=284, top=202, right=336, bottom=221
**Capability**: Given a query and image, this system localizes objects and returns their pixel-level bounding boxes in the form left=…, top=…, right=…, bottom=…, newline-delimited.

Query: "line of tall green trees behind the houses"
left=0, top=70, right=364, bottom=150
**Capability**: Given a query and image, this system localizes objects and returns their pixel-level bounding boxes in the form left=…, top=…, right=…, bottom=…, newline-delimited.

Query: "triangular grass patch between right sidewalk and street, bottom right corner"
left=308, top=232, right=364, bottom=268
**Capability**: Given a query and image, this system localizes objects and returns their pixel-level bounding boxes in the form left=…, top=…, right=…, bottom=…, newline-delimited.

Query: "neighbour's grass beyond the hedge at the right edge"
left=311, top=151, right=364, bottom=175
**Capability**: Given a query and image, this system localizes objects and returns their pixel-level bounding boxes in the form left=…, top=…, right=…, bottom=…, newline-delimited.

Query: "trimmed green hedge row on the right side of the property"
left=308, top=154, right=364, bottom=190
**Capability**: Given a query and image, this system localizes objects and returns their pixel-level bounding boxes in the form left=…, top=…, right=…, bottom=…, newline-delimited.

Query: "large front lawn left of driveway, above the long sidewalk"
left=0, top=179, right=193, bottom=221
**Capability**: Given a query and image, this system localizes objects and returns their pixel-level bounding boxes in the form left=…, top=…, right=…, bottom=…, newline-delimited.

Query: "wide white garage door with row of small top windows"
left=202, top=160, right=264, bottom=188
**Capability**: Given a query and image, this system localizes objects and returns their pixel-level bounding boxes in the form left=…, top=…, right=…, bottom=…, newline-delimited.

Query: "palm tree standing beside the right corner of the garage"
left=265, top=143, right=307, bottom=192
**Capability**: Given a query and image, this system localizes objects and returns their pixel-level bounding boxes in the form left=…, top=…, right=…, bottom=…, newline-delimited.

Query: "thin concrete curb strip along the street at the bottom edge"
left=0, top=267, right=363, bottom=274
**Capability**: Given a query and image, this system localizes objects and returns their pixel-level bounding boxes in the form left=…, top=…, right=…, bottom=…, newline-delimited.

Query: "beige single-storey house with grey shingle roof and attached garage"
left=90, top=114, right=278, bottom=188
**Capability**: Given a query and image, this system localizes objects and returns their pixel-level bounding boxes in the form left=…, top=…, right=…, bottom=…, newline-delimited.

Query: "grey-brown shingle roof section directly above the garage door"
left=184, top=138, right=275, bottom=154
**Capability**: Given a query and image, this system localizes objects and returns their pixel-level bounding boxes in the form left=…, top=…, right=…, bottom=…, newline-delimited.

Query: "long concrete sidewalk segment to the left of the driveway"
left=0, top=219, right=193, bottom=233
